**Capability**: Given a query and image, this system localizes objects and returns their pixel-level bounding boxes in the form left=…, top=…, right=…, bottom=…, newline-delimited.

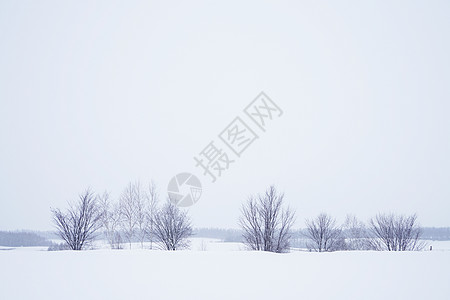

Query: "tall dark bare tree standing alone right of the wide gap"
left=239, top=186, right=295, bottom=252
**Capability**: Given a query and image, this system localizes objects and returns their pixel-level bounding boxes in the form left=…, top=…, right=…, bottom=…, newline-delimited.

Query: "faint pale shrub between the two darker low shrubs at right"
left=342, top=215, right=372, bottom=250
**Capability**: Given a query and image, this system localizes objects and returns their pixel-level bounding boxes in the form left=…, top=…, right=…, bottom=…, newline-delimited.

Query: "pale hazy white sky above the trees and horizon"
left=0, top=0, right=450, bottom=229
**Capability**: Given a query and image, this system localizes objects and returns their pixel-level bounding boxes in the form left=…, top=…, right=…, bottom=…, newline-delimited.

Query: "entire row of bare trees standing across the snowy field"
left=52, top=182, right=425, bottom=253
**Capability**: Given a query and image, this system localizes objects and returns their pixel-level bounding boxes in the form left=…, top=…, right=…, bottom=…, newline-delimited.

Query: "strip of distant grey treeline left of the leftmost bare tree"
left=0, top=231, right=51, bottom=247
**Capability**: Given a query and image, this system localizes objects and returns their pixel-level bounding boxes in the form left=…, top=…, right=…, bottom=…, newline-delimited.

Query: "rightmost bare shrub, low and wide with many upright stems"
left=370, top=214, right=425, bottom=251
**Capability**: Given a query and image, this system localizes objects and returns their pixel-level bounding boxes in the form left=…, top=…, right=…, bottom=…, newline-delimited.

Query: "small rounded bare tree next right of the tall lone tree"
left=306, top=213, right=343, bottom=252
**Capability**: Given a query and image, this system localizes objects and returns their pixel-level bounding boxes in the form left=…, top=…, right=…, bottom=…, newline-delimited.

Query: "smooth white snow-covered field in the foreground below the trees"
left=0, top=239, right=450, bottom=300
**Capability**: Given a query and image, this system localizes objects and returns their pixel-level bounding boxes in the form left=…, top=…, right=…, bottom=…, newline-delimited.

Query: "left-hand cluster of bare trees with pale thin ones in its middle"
left=52, top=182, right=192, bottom=250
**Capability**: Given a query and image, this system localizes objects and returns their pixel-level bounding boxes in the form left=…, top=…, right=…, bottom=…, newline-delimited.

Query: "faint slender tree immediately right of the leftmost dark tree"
left=99, top=192, right=122, bottom=249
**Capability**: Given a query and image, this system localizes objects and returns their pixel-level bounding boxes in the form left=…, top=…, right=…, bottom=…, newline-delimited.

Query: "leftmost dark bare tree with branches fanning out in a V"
left=52, top=190, right=102, bottom=250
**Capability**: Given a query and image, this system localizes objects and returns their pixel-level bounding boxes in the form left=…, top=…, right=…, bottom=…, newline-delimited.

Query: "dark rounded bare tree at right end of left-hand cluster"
left=153, top=200, right=192, bottom=250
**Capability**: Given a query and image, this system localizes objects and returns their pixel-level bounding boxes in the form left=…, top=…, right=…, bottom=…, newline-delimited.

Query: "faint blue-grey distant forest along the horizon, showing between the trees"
left=0, top=227, right=450, bottom=247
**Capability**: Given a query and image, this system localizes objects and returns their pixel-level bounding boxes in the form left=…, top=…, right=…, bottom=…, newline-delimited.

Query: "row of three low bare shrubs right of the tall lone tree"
left=305, top=213, right=425, bottom=252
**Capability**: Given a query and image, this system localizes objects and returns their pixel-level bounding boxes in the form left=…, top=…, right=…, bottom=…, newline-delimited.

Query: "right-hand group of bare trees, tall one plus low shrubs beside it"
left=239, top=186, right=425, bottom=252
